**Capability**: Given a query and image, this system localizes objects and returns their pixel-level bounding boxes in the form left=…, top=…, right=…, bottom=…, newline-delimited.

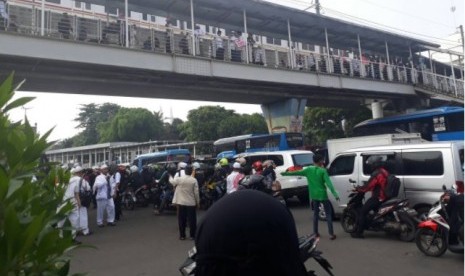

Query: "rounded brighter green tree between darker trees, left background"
left=99, top=108, right=163, bottom=142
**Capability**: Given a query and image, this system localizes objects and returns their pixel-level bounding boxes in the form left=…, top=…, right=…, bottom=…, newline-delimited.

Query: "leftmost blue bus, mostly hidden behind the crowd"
left=132, top=149, right=191, bottom=171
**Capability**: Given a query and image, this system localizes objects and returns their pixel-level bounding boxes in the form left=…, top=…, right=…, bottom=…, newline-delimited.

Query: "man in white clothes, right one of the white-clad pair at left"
left=94, top=165, right=116, bottom=227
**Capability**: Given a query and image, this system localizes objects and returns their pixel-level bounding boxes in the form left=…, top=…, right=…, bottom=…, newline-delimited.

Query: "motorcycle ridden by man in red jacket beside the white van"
left=341, top=189, right=419, bottom=242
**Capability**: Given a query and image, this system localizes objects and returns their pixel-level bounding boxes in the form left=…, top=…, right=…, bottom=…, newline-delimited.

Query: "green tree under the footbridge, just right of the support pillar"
left=303, top=107, right=371, bottom=145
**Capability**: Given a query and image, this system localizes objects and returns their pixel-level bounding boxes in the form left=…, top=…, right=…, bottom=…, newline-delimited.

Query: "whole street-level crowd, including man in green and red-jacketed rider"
left=59, top=151, right=460, bottom=248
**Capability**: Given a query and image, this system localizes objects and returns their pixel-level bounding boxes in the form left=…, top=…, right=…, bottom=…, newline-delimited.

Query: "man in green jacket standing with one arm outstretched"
left=281, top=154, right=339, bottom=240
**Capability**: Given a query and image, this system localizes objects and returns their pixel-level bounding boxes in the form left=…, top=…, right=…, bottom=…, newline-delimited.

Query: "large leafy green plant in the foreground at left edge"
left=0, top=74, right=74, bottom=275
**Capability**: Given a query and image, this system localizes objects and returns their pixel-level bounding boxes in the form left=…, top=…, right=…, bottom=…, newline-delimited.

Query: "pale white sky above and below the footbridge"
left=10, top=0, right=465, bottom=140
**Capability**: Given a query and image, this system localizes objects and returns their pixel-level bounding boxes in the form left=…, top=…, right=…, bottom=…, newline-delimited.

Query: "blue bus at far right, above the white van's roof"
left=354, top=106, right=464, bottom=141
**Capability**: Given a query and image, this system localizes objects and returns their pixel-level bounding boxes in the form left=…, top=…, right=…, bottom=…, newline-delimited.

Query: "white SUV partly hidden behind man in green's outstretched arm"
left=237, top=150, right=313, bottom=203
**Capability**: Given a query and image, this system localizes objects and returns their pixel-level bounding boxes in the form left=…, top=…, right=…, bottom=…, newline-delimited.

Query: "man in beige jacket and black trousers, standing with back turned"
left=169, top=165, right=200, bottom=240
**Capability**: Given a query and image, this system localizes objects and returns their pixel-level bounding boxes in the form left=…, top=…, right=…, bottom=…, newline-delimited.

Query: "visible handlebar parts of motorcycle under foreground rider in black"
left=179, top=235, right=333, bottom=276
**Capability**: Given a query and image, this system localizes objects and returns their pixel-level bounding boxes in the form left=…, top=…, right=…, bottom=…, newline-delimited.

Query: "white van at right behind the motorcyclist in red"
left=321, top=141, right=464, bottom=217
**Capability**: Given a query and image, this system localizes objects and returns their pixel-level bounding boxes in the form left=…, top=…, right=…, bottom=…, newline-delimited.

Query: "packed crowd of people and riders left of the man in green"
left=59, top=158, right=276, bottom=243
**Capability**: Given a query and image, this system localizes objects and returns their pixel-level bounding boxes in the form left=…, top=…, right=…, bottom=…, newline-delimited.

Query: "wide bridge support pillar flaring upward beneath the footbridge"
left=261, top=98, right=307, bottom=133
